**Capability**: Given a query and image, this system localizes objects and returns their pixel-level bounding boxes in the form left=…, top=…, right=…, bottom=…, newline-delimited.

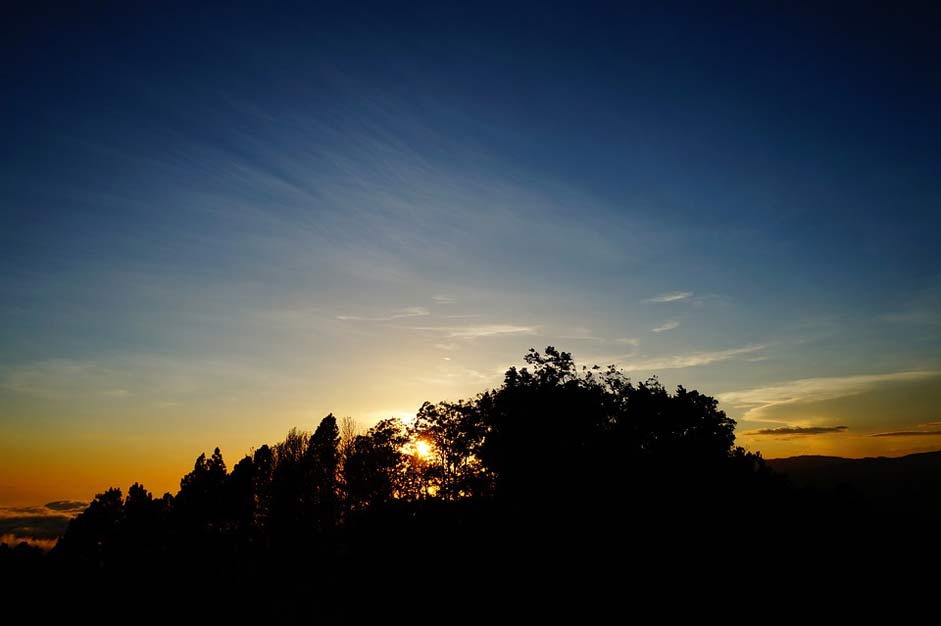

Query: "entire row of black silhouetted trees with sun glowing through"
left=47, top=347, right=771, bottom=569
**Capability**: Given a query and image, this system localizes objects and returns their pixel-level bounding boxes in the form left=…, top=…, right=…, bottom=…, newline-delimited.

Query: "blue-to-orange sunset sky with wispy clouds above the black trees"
left=0, top=2, right=941, bottom=508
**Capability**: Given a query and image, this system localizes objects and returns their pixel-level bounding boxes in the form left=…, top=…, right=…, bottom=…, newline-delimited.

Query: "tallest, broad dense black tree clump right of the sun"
left=477, top=346, right=735, bottom=499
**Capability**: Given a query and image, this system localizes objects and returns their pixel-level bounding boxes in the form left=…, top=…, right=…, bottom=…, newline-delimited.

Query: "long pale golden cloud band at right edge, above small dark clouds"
left=717, top=370, right=941, bottom=419
